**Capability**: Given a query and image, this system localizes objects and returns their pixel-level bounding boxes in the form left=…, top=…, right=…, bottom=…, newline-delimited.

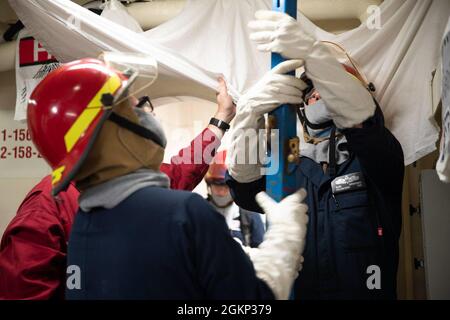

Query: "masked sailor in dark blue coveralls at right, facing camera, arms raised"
left=227, top=12, right=404, bottom=299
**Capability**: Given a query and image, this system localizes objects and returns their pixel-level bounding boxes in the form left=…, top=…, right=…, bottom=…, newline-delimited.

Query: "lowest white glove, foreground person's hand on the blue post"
left=243, top=189, right=308, bottom=300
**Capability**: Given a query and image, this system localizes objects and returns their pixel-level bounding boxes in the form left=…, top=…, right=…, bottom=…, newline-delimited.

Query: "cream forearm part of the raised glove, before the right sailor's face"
left=305, top=42, right=376, bottom=129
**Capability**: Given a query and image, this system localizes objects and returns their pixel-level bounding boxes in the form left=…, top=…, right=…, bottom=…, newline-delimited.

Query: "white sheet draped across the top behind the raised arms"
left=9, top=0, right=450, bottom=164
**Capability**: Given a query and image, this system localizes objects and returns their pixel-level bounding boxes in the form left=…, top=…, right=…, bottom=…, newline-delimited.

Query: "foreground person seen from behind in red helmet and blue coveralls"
left=0, top=55, right=308, bottom=299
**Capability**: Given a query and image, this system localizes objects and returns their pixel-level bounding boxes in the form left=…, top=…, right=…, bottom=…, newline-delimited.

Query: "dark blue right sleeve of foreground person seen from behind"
left=184, top=195, right=274, bottom=300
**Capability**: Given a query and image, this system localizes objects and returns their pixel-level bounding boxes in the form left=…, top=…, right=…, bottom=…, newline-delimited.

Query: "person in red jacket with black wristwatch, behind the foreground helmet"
left=0, top=52, right=235, bottom=299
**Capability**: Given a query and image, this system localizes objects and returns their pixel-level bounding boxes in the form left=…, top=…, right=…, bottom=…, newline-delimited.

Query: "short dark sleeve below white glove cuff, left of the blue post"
left=225, top=171, right=266, bottom=213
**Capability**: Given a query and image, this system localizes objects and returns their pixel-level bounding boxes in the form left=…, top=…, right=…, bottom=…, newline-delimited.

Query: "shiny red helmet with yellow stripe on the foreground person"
left=27, top=59, right=133, bottom=195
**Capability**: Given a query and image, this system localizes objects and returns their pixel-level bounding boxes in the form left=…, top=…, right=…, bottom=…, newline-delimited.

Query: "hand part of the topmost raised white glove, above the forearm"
left=248, top=10, right=316, bottom=59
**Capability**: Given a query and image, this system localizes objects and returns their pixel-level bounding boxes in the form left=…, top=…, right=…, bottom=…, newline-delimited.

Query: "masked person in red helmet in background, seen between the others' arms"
left=205, top=150, right=264, bottom=248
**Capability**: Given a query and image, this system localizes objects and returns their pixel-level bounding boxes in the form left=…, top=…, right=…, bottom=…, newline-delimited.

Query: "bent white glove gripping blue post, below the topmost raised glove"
left=227, top=60, right=306, bottom=183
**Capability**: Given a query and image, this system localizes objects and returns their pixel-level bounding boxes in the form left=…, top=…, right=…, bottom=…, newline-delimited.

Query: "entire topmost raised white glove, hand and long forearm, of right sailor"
left=249, top=11, right=376, bottom=129
